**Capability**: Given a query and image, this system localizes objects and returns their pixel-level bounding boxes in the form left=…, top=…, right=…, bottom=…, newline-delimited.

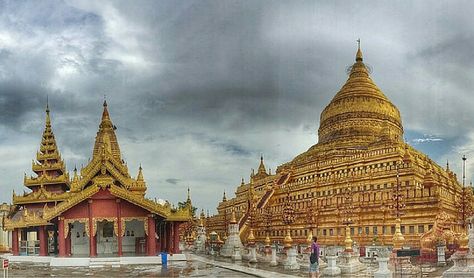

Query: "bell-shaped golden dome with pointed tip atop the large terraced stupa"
left=318, top=48, right=403, bottom=147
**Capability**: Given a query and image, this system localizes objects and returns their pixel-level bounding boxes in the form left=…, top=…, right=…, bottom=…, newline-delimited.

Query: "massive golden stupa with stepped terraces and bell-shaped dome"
left=206, top=47, right=473, bottom=250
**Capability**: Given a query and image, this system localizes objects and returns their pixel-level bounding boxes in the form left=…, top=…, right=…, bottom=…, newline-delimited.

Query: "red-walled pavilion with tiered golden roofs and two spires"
left=3, top=101, right=192, bottom=257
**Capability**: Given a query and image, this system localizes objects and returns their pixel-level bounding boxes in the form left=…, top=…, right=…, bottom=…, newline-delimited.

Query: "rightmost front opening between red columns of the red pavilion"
left=122, top=219, right=146, bottom=256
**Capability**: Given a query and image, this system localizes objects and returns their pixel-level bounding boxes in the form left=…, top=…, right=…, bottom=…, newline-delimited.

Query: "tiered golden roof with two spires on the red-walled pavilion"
left=4, top=102, right=192, bottom=229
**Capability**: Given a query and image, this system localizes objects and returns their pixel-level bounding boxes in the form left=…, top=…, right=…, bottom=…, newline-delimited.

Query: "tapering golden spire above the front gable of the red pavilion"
left=92, top=100, right=122, bottom=162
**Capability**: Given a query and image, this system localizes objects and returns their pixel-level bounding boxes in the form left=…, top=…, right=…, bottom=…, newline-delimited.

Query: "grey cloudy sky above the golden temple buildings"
left=0, top=0, right=474, bottom=212
